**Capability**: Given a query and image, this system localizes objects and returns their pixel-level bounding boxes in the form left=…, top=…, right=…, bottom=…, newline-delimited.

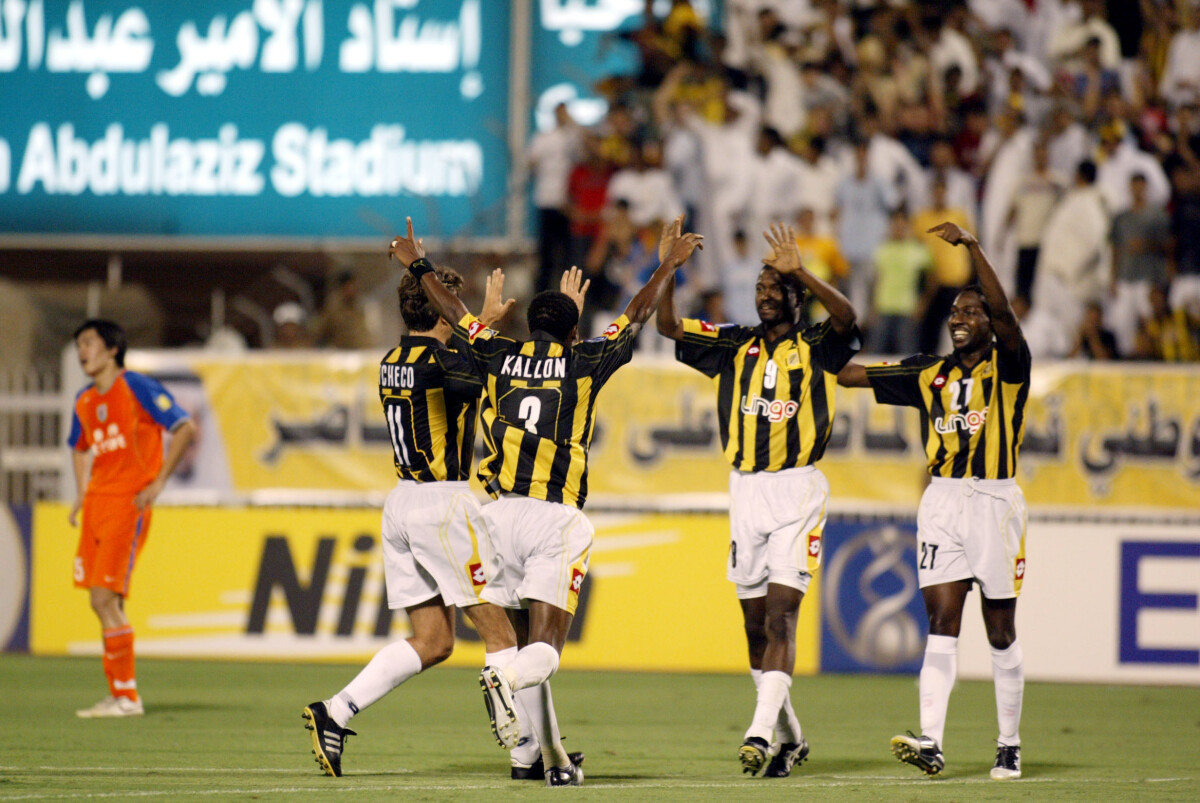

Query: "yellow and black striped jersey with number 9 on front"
left=676, top=318, right=859, bottom=472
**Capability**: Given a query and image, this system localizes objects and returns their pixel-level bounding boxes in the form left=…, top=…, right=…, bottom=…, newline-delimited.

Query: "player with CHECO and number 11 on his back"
left=304, top=270, right=517, bottom=777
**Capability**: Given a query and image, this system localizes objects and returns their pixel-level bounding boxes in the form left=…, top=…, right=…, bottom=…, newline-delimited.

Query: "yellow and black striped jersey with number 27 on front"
left=866, top=338, right=1033, bottom=480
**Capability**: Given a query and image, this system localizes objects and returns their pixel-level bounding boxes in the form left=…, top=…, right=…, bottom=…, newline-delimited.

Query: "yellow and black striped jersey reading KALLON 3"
left=451, top=313, right=636, bottom=508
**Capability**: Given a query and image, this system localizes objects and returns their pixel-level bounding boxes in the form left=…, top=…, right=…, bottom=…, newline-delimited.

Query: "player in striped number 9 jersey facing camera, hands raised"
left=658, top=226, right=859, bottom=778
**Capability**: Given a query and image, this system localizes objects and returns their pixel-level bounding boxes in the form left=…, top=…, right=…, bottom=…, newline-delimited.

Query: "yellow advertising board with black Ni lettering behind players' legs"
left=30, top=504, right=821, bottom=675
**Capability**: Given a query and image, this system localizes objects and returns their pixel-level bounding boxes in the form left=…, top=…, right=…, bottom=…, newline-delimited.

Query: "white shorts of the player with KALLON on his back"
left=482, top=495, right=595, bottom=613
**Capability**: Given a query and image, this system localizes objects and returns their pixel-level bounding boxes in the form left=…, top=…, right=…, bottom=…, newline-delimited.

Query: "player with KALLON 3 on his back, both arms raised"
left=391, top=215, right=701, bottom=786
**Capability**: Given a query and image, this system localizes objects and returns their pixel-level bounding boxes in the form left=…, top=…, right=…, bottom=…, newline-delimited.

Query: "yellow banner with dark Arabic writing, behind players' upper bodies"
left=131, top=353, right=1200, bottom=509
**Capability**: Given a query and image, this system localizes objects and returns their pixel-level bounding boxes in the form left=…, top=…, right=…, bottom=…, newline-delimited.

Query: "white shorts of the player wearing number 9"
left=725, top=466, right=829, bottom=599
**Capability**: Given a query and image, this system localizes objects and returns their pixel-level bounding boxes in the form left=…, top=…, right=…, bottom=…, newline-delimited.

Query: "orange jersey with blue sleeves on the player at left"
left=67, top=371, right=187, bottom=496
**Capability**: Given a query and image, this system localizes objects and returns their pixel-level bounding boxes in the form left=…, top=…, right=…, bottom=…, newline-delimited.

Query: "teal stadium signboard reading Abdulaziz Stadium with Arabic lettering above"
left=0, top=0, right=509, bottom=238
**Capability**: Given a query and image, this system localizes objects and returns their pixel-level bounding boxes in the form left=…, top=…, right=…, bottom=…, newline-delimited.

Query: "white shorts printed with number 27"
left=917, top=477, right=1028, bottom=599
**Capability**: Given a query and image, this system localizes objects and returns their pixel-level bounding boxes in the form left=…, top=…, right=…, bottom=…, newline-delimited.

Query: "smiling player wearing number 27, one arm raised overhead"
left=838, top=223, right=1031, bottom=780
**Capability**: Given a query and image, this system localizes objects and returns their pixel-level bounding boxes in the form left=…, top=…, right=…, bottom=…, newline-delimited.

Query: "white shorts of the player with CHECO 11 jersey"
left=383, top=480, right=492, bottom=609
